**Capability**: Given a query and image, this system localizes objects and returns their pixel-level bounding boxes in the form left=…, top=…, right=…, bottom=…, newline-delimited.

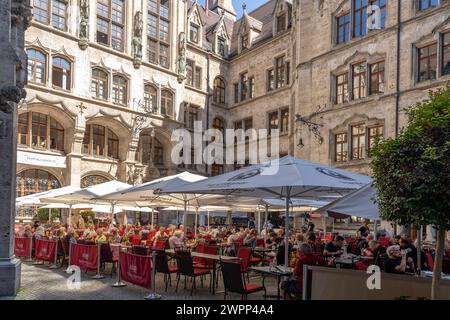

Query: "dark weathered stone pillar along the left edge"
left=0, top=0, right=31, bottom=296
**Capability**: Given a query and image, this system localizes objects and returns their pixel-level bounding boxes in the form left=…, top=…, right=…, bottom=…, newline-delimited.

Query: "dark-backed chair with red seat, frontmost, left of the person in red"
left=220, top=261, right=266, bottom=300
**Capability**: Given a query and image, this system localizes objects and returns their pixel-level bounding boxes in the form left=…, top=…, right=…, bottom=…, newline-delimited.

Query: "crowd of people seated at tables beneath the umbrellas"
left=17, top=223, right=450, bottom=296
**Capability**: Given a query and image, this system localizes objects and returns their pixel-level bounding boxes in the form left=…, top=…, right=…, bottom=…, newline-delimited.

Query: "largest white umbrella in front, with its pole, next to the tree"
left=161, top=156, right=372, bottom=267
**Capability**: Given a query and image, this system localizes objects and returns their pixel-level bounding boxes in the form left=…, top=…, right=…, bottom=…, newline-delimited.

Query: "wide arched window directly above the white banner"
left=17, top=112, right=64, bottom=151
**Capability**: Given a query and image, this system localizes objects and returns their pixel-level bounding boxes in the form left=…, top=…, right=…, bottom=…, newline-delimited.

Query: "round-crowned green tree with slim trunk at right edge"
left=372, top=88, right=450, bottom=299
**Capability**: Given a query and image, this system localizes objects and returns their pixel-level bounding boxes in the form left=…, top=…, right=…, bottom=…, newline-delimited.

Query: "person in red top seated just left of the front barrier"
left=281, top=243, right=325, bottom=297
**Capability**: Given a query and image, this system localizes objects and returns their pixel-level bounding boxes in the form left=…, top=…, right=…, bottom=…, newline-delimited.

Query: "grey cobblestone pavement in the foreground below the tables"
left=0, top=262, right=277, bottom=300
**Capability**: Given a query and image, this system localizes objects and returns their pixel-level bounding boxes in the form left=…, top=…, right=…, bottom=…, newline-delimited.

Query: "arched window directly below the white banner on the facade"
left=17, top=169, right=61, bottom=197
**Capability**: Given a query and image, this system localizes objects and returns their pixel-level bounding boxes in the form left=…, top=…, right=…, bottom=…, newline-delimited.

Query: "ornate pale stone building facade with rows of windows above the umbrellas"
left=17, top=0, right=450, bottom=219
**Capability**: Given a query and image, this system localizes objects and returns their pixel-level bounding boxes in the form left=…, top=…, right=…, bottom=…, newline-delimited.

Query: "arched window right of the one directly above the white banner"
left=83, top=124, right=119, bottom=159
